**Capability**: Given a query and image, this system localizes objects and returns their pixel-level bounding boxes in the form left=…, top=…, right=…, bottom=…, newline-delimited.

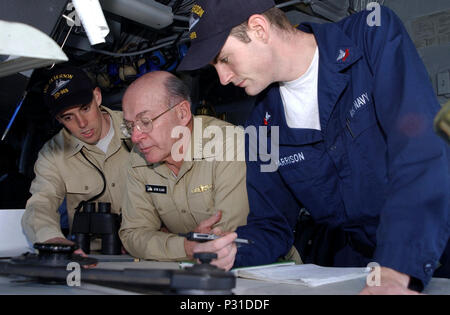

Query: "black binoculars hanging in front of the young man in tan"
left=72, top=202, right=122, bottom=255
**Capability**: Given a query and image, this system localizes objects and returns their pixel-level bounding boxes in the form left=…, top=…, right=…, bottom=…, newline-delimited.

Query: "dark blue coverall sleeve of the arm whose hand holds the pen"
left=234, top=130, right=299, bottom=267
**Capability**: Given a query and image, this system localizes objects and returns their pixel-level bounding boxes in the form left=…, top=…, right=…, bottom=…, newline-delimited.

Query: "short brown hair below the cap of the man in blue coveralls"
left=230, top=8, right=294, bottom=44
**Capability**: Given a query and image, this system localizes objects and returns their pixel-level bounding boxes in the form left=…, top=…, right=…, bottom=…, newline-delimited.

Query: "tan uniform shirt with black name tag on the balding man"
left=119, top=116, right=249, bottom=261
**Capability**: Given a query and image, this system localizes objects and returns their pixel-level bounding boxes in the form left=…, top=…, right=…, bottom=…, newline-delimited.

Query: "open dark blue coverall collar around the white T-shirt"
left=260, top=23, right=363, bottom=145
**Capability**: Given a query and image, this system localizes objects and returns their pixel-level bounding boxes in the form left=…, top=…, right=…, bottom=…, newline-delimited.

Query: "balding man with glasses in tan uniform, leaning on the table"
left=119, top=72, right=249, bottom=261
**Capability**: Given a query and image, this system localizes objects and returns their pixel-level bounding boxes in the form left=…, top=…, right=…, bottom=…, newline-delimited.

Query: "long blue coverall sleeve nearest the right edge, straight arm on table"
left=364, top=7, right=450, bottom=285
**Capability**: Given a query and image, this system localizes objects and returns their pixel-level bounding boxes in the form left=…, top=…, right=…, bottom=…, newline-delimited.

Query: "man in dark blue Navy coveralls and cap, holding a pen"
left=178, top=0, right=450, bottom=294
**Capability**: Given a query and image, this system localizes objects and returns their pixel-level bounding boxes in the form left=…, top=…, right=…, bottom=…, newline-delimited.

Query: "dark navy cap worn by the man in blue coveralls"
left=177, top=0, right=275, bottom=71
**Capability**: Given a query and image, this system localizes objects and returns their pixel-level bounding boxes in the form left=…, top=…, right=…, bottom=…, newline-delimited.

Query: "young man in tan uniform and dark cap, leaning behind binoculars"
left=22, top=67, right=129, bottom=253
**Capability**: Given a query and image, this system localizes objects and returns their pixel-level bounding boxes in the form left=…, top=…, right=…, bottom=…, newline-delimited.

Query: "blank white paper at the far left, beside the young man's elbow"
left=0, top=209, right=34, bottom=257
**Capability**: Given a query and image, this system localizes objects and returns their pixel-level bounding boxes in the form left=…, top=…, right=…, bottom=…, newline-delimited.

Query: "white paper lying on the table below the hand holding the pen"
left=235, top=264, right=370, bottom=287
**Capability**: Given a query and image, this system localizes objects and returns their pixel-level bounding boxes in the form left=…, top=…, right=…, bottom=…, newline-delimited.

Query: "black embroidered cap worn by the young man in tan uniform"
left=43, top=66, right=95, bottom=117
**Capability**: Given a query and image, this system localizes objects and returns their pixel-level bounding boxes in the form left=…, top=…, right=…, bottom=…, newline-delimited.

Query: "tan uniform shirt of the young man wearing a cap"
left=22, top=107, right=129, bottom=243
